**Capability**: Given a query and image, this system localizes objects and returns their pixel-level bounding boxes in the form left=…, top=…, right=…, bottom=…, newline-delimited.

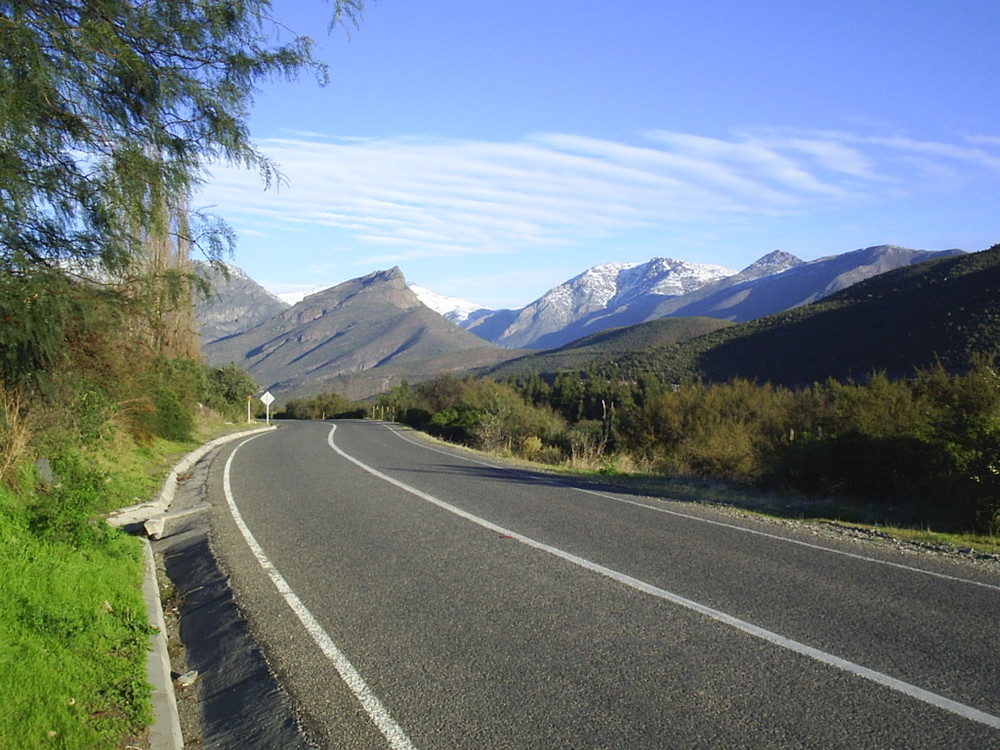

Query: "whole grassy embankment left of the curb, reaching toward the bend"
left=0, top=423, right=241, bottom=750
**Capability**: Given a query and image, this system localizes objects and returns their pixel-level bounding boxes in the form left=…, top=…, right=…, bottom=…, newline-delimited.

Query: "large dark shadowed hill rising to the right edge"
left=620, top=245, right=1000, bottom=386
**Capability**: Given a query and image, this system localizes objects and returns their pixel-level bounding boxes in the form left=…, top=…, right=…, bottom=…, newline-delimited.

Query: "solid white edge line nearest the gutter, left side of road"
left=222, top=435, right=416, bottom=750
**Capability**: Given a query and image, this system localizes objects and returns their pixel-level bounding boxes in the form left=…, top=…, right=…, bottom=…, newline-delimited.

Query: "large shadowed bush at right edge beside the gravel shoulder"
left=767, top=358, right=1000, bottom=530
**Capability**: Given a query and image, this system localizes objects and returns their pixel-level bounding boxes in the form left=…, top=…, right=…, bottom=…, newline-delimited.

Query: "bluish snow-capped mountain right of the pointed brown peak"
left=468, top=258, right=736, bottom=348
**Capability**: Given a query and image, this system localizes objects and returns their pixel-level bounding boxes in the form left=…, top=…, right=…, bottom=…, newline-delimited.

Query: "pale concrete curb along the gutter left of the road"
left=122, top=426, right=275, bottom=750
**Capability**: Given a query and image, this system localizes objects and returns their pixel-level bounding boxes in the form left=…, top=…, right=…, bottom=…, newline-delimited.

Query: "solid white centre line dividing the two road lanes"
left=336, top=425, right=1000, bottom=729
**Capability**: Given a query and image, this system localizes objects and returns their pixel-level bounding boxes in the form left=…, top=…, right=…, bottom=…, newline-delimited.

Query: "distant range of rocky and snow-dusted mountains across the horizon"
left=197, top=245, right=963, bottom=399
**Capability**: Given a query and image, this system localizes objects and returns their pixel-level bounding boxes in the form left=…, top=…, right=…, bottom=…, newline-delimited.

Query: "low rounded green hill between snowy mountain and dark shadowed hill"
left=489, top=317, right=733, bottom=377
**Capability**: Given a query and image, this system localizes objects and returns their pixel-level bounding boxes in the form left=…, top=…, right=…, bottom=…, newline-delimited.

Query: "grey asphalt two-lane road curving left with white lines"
left=203, top=422, right=1000, bottom=750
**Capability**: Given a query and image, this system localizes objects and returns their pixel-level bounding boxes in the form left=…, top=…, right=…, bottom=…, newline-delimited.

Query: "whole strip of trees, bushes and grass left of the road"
left=0, top=0, right=362, bottom=749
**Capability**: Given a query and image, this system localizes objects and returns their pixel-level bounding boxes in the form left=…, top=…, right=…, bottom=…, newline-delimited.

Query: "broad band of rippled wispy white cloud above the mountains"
left=200, top=129, right=1000, bottom=262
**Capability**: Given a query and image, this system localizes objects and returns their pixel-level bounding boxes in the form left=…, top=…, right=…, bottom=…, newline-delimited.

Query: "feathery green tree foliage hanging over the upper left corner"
left=0, top=0, right=363, bottom=385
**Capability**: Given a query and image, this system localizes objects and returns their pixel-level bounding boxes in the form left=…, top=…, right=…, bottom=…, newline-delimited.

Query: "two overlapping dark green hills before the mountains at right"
left=486, top=245, right=1000, bottom=387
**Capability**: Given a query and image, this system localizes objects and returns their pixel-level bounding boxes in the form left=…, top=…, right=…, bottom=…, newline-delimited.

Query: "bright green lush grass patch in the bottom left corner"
left=0, top=490, right=151, bottom=750
